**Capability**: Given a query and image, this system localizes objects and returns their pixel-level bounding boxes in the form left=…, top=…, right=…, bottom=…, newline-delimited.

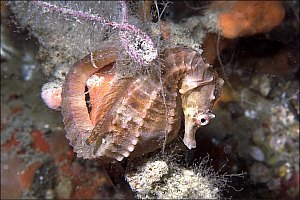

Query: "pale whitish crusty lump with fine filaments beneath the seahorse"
left=125, top=149, right=230, bottom=199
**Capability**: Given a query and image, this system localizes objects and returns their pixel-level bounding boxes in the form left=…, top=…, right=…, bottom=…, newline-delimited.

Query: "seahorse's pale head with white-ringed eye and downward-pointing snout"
left=179, top=66, right=224, bottom=149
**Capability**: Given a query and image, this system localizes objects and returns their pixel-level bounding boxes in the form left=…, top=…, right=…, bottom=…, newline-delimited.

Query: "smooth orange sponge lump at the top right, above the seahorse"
left=217, top=1, right=285, bottom=39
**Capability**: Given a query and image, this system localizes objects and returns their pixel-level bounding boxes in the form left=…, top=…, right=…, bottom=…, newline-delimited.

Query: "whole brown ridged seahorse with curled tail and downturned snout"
left=61, top=47, right=224, bottom=161
